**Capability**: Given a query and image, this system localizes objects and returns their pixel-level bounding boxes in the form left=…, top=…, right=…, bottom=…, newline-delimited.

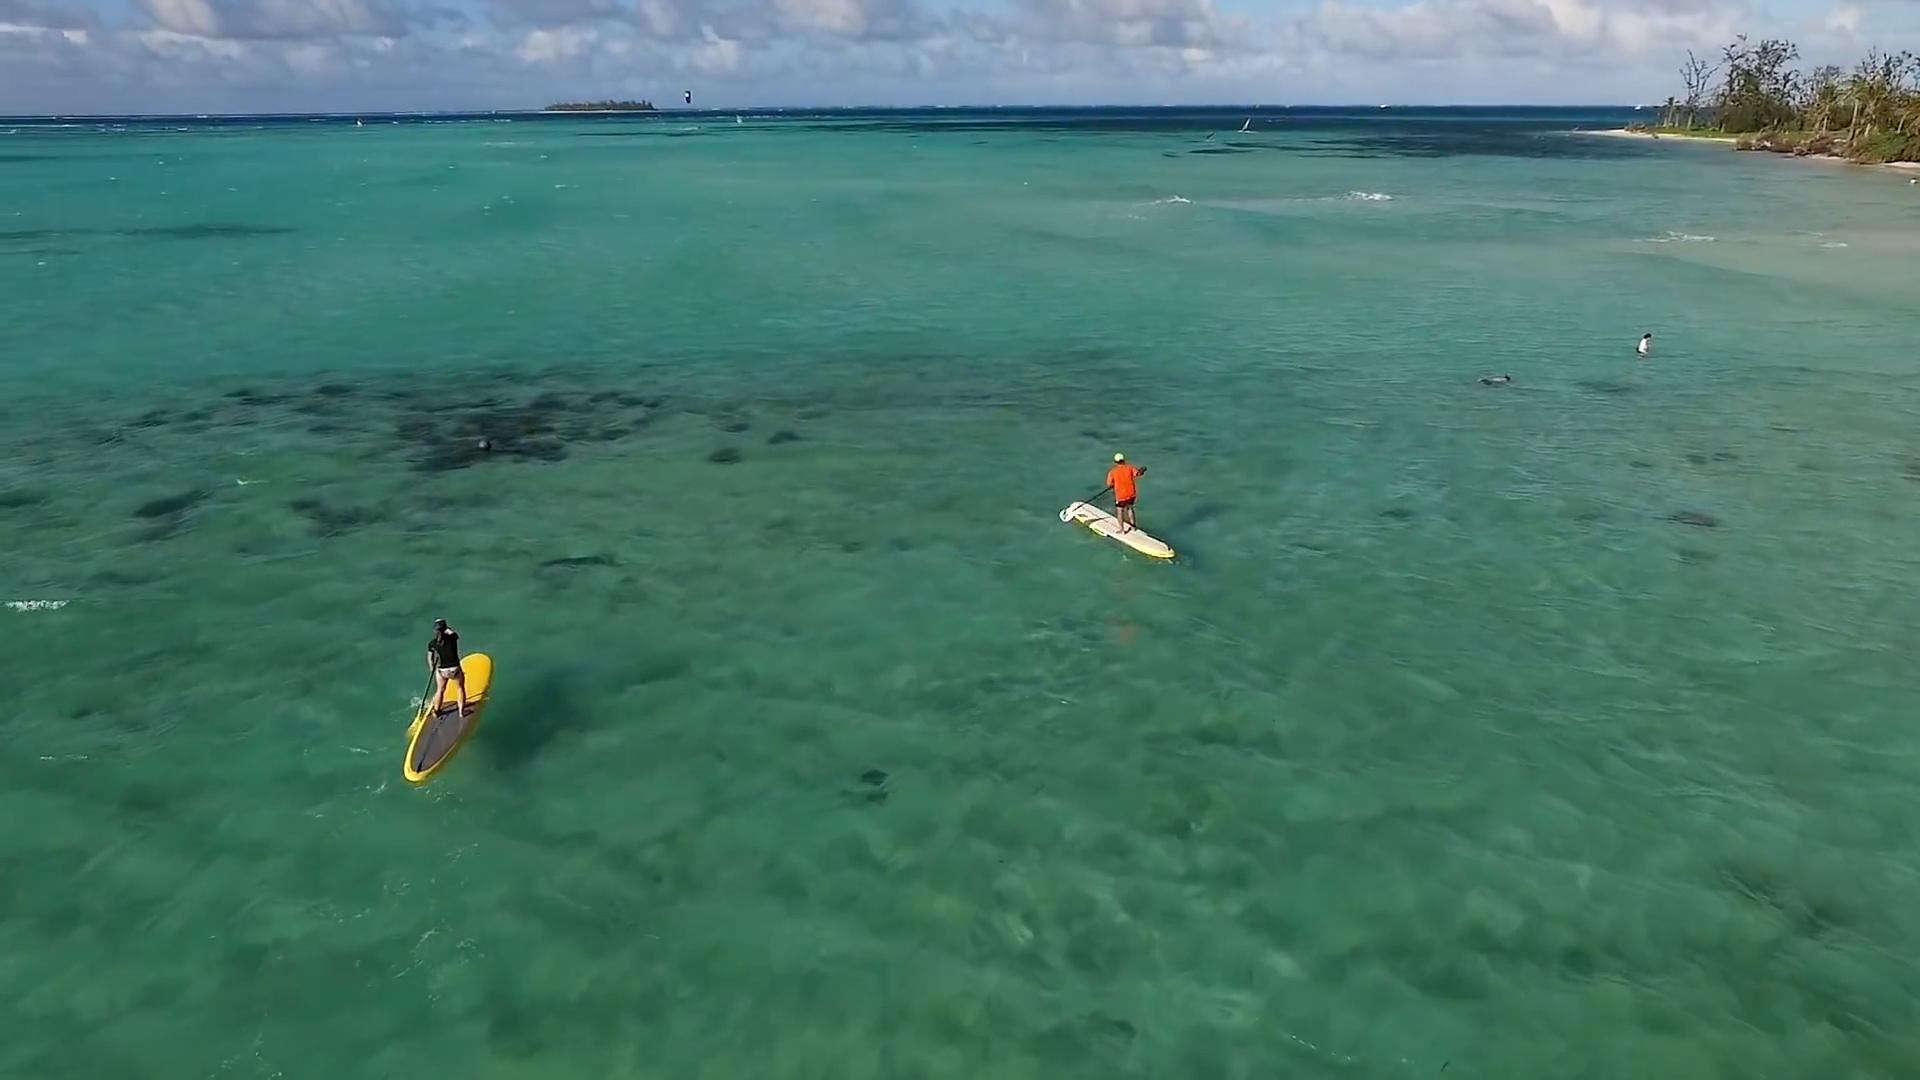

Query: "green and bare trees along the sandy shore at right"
left=1661, top=35, right=1920, bottom=161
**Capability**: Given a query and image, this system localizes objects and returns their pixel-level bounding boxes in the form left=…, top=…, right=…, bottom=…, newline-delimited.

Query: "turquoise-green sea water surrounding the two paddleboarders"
left=0, top=110, right=1920, bottom=1080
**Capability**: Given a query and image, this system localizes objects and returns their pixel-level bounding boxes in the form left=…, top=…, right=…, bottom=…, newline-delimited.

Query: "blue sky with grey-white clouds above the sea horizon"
left=0, top=0, right=1920, bottom=113
